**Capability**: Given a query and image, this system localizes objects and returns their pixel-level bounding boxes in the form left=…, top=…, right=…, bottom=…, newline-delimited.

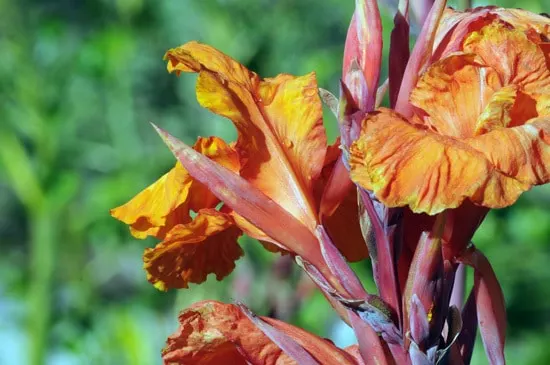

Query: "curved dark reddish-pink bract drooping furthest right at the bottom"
left=459, top=246, right=506, bottom=364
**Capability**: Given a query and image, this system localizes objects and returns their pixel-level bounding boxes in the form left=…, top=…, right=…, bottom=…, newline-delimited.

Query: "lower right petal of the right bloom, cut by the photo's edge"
left=465, top=117, right=550, bottom=185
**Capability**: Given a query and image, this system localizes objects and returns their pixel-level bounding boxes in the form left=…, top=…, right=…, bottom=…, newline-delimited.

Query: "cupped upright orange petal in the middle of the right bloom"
left=410, top=54, right=501, bottom=138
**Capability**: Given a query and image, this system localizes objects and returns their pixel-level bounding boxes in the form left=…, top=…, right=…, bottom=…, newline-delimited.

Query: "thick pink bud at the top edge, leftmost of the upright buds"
left=342, top=0, right=382, bottom=110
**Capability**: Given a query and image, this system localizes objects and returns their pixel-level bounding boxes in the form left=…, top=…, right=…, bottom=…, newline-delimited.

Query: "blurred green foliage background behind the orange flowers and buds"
left=0, top=0, right=550, bottom=365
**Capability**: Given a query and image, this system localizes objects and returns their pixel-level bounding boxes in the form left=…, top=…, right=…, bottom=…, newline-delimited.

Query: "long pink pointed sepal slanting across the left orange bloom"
left=153, top=125, right=322, bottom=264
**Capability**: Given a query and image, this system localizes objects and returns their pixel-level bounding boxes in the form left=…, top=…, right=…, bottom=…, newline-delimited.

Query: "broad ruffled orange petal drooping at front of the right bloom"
left=350, top=109, right=530, bottom=215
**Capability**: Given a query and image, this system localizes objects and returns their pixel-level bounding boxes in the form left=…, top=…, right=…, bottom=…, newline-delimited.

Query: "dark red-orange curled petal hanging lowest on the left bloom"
left=143, top=209, right=243, bottom=291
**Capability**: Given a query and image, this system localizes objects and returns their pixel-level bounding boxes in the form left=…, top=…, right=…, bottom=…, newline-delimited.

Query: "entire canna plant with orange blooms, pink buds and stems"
left=111, top=0, right=550, bottom=364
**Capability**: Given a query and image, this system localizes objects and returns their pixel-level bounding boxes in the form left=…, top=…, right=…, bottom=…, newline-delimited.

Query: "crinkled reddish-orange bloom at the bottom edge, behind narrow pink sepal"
left=162, top=301, right=359, bottom=365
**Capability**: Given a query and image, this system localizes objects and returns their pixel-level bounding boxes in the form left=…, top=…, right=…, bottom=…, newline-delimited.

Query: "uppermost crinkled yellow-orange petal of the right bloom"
left=463, top=21, right=550, bottom=101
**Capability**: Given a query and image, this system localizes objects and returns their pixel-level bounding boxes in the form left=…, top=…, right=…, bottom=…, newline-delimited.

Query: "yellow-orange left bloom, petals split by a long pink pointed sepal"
left=111, top=42, right=368, bottom=290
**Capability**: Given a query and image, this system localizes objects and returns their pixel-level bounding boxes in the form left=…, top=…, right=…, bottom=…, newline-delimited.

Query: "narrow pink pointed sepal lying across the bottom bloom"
left=237, top=303, right=319, bottom=365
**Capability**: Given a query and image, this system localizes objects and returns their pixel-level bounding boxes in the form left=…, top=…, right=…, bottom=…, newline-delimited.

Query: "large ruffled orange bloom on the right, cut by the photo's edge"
left=350, top=17, right=550, bottom=214
